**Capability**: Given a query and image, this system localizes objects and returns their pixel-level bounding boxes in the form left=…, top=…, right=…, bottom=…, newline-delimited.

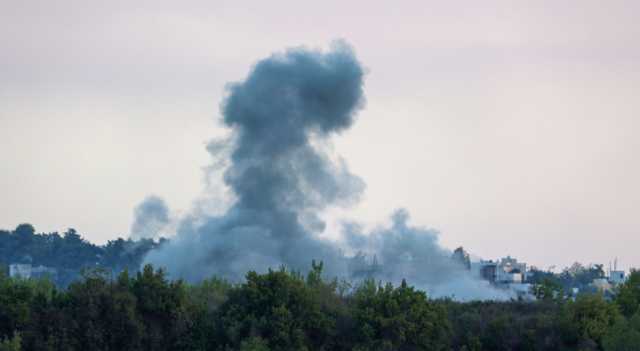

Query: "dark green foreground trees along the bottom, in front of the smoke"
left=0, top=263, right=640, bottom=351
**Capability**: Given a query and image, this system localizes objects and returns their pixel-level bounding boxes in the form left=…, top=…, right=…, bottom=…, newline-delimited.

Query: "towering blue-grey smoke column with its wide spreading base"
left=147, top=42, right=510, bottom=298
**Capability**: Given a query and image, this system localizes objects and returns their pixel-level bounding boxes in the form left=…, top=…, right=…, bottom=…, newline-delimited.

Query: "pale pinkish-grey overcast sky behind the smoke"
left=0, top=0, right=640, bottom=268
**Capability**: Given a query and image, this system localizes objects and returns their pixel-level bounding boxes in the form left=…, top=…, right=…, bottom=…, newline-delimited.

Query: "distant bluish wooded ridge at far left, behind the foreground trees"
left=0, top=224, right=164, bottom=287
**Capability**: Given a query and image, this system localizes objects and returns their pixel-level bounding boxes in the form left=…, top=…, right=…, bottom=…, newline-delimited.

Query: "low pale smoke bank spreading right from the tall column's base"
left=343, top=209, right=502, bottom=300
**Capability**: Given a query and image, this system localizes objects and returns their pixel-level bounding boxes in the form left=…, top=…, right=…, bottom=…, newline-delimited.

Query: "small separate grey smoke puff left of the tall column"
left=130, top=195, right=170, bottom=240
